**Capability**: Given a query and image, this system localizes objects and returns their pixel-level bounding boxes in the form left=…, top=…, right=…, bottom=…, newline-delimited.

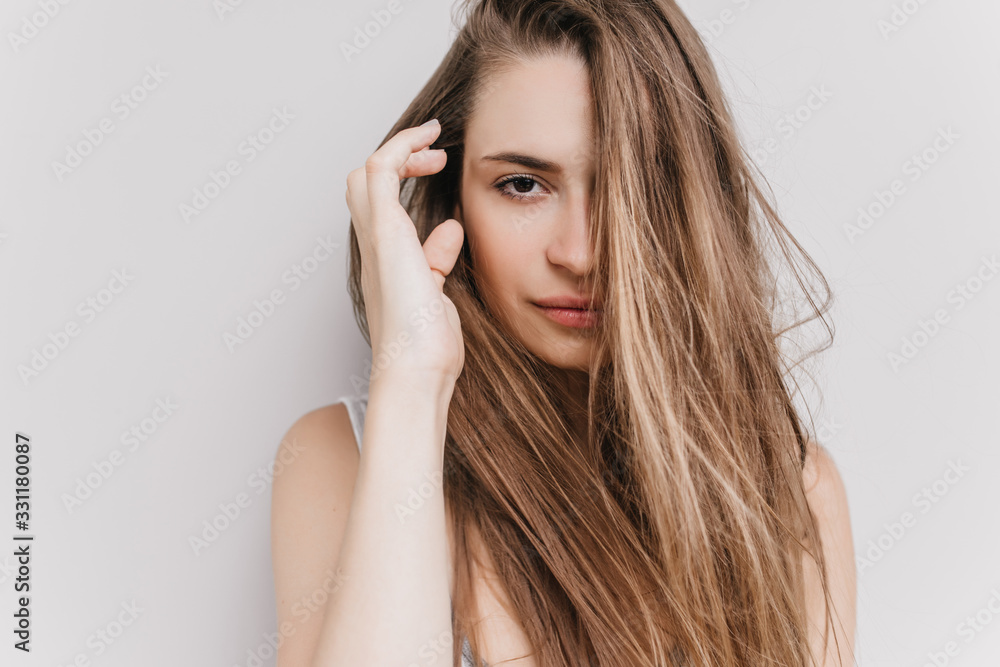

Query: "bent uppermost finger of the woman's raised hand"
left=365, top=123, right=441, bottom=220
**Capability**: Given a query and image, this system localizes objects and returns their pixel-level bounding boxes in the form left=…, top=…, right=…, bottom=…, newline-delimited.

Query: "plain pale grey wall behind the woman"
left=0, top=0, right=1000, bottom=667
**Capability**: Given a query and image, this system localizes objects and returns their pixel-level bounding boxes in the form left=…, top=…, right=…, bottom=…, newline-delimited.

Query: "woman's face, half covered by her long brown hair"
left=456, top=51, right=600, bottom=370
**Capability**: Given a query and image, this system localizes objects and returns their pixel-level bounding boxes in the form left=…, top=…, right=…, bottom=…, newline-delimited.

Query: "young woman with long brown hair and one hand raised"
left=272, top=0, right=855, bottom=667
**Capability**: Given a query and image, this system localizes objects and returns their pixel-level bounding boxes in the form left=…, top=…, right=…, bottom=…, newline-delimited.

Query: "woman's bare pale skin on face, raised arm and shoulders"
left=272, top=51, right=856, bottom=667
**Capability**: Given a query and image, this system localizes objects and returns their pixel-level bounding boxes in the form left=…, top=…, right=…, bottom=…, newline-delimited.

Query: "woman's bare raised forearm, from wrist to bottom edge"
left=312, top=376, right=454, bottom=667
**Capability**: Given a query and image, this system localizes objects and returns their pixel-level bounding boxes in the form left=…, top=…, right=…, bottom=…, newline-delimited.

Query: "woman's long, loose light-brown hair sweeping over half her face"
left=349, top=0, right=833, bottom=667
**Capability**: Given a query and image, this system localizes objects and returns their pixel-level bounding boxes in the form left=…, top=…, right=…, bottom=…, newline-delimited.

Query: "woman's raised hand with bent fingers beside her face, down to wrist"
left=347, top=120, right=465, bottom=385
